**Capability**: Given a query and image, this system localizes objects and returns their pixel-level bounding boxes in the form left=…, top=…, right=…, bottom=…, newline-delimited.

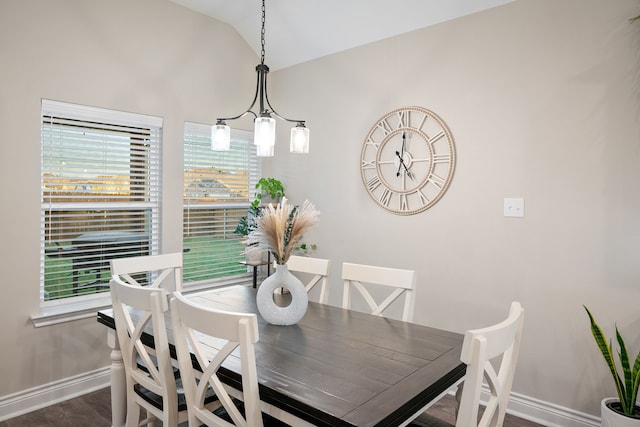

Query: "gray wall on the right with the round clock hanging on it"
left=272, top=0, right=640, bottom=414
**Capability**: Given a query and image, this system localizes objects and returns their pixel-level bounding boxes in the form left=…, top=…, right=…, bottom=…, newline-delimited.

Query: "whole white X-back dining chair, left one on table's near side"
left=110, top=280, right=216, bottom=427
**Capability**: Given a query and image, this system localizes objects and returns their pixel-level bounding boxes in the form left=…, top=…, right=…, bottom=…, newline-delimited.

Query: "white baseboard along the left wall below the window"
left=0, top=367, right=111, bottom=421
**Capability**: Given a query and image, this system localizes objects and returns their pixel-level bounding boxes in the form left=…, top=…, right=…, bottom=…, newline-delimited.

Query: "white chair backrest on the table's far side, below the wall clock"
left=342, top=262, right=416, bottom=322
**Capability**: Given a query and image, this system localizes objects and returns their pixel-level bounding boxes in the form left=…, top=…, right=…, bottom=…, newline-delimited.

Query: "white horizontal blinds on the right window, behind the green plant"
left=183, top=123, right=260, bottom=286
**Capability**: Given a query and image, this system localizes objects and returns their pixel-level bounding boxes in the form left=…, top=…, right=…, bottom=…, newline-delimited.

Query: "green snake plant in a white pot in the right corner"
left=584, top=306, right=640, bottom=427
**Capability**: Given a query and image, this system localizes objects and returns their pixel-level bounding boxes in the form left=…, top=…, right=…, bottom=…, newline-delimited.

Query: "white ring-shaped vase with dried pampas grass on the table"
left=247, top=198, right=320, bottom=325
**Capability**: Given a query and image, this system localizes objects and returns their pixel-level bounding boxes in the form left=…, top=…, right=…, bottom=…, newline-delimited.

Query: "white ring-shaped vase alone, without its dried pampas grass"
left=256, top=264, right=309, bottom=325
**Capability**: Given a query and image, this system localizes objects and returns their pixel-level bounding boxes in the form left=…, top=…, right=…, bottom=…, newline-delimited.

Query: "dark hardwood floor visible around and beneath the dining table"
left=0, top=388, right=542, bottom=427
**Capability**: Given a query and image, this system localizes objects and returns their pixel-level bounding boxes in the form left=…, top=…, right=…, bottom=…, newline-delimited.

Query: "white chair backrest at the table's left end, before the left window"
left=110, top=253, right=182, bottom=292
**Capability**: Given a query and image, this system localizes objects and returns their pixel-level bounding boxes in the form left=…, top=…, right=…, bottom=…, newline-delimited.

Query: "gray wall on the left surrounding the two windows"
left=0, top=0, right=258, bottom=396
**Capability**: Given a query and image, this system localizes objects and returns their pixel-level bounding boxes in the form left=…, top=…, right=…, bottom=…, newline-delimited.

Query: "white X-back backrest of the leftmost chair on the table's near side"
left=110, top=280, right=178, bottom=425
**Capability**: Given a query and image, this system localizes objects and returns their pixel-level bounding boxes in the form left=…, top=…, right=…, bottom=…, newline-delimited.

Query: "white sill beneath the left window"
left=31, top=292, right=111, bottom=328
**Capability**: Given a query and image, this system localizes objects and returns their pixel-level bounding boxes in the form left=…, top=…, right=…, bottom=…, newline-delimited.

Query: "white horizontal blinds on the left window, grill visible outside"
left=41, top=100, right=162, bottom=304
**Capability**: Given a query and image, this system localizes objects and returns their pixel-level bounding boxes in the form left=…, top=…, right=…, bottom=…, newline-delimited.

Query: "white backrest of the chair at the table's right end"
left=456, top=302, right=524, bottom=427
